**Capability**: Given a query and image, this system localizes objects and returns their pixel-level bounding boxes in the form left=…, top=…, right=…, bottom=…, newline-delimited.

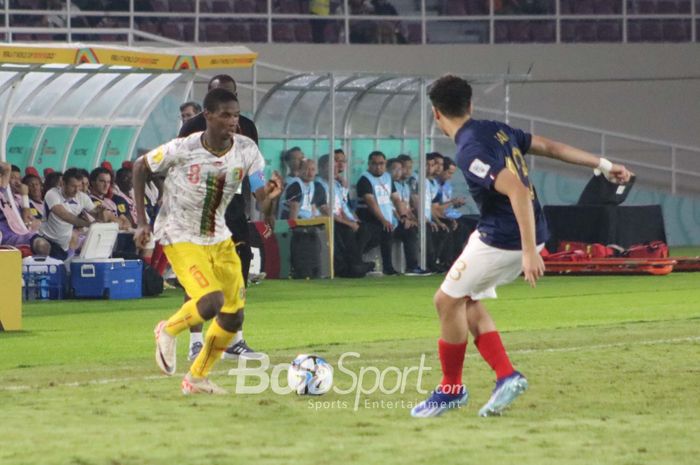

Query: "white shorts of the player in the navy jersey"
left=440, top=231, right=544, bottom=300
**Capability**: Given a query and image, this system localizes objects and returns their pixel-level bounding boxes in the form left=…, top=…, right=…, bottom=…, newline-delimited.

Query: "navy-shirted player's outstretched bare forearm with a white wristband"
left=529, top=135, right=632, bottom=184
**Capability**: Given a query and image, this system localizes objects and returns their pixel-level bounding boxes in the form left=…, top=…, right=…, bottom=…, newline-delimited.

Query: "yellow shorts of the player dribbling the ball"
left=163, top=239, right=245, bottom=313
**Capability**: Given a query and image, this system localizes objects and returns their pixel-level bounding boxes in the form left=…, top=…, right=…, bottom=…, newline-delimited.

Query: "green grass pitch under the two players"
left=0, top=273, right=700, bottom=465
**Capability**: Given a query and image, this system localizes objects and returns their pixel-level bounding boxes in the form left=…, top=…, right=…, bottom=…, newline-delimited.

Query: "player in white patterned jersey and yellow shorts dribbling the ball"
left=134, top=89, right=282, bottom=394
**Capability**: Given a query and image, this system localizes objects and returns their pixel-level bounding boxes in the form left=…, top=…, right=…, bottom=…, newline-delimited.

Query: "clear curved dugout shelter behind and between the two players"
left=255, top=73, right=529, bottom=267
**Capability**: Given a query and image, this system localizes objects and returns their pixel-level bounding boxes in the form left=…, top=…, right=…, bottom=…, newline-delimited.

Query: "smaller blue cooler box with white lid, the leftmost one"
left=22, top=257, right=67, bottom=300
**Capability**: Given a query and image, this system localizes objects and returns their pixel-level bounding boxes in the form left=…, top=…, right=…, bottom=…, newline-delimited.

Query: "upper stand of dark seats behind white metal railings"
left=0, top=0, right=700, bottom=44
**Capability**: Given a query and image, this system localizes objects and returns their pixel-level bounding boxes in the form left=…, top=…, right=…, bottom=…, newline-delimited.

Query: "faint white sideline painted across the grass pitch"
left=0, top=336, right=700, bottom=391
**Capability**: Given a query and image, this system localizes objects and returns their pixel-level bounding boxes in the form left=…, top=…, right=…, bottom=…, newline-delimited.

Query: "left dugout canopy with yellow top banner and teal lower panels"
left=0, top=43, right=257, bottom=173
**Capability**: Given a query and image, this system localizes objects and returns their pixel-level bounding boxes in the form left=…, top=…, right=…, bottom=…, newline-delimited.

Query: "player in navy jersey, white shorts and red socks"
left=411, top=75, right=630, bottom=417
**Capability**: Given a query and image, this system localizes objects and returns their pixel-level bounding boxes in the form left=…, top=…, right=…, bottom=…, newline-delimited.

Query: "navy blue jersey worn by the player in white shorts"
left=455, top=119, right=547, bottom=250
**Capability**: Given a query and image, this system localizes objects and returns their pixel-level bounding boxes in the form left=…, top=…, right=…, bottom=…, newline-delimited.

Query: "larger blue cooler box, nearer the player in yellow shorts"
left=70, top=258, right=143, bottom=299
